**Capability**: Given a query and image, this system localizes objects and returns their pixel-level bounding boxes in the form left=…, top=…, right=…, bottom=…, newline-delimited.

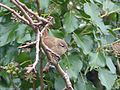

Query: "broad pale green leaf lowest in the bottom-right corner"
left=98, top=69, right=117, bottom=90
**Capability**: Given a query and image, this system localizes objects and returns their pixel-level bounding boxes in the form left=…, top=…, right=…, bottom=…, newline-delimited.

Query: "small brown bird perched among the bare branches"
left=43, top=31, right=68, bottom=72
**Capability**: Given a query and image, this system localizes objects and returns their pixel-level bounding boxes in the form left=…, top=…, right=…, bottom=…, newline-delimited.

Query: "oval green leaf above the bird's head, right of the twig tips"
left=63, top=12, right=78, bottom=33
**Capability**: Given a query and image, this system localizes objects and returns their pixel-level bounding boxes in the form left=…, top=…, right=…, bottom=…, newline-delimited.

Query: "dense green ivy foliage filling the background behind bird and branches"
left=0, top=0, right=120, bottom=90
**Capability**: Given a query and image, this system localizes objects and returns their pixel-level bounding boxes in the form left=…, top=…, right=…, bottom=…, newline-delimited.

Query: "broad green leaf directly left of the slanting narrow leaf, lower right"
left=89, top=52, right=106, bottom=68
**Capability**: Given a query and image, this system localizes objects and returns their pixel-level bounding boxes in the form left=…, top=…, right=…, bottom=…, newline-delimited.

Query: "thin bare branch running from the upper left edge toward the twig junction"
left=0, top=3, right=30, bottom=25
